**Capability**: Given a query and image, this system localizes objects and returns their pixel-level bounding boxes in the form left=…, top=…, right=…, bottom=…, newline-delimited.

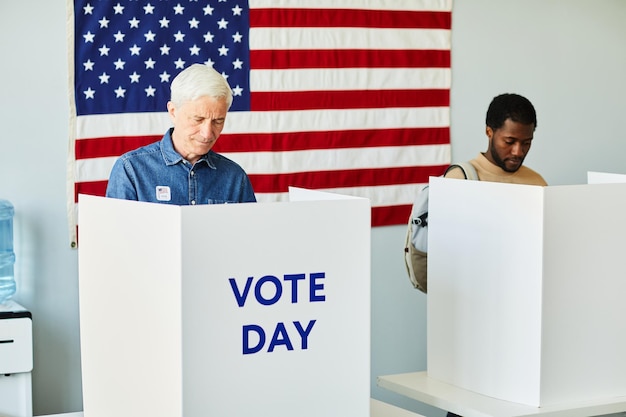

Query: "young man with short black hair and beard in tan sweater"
left=446, top=94, right=547, bottom=185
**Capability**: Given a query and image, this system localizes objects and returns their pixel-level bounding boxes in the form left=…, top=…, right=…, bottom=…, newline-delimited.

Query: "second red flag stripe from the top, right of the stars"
left=250, top=49, right=450, bottom=69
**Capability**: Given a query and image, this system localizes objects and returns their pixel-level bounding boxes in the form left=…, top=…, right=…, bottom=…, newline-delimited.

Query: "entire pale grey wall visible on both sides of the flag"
left=0, top=0, right=626, bottom=417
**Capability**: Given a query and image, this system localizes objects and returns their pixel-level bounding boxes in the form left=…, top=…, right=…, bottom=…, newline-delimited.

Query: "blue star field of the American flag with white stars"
left=76, top=0, right=254, bottom=112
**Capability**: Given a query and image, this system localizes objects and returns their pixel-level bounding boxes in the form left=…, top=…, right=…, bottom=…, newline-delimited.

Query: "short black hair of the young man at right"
left=486, top=93, right=537, bottom=130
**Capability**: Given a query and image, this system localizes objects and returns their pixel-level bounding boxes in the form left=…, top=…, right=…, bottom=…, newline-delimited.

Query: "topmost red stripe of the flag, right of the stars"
left=250, top=8, right=452, bottom=29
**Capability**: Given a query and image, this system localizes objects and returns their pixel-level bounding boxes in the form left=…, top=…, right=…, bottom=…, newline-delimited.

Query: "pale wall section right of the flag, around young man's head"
left=452, top=0, right=626, bottom=185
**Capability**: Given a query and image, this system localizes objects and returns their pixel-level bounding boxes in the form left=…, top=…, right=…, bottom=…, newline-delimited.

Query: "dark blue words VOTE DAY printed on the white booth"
left=228, top=272, right=326, bottom=355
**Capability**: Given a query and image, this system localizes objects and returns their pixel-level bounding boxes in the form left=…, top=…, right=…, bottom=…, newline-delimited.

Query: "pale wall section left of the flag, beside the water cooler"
left=0, top=0, right=82, bottom=414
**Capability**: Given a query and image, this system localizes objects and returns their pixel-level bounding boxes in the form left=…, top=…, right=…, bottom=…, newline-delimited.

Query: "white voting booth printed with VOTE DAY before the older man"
left=79, top=189, right=370, bottom=417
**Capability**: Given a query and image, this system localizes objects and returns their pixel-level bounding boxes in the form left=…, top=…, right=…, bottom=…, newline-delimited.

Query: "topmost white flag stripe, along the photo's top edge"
left=248, top=0, right=452, bottom=11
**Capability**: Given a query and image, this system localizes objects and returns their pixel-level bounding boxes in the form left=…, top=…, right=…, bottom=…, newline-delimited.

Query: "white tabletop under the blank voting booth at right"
left=378, top=371, right=626, bottom=417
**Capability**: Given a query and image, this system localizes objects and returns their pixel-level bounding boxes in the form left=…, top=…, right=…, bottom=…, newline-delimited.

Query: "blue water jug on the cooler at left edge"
left=0, top=199, right=15, bottom=304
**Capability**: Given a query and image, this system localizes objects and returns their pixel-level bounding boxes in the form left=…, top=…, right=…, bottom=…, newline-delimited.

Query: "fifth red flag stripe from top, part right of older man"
left=249, top=165, right=447, bottom=193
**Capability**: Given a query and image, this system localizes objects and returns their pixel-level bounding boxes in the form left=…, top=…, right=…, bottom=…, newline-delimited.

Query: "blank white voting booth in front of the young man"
left=427, top=178, right=626, bottom=406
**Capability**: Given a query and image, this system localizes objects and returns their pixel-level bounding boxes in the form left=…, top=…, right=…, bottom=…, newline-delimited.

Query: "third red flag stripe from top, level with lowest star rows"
left=250, top=89, right=450, bottom=111
